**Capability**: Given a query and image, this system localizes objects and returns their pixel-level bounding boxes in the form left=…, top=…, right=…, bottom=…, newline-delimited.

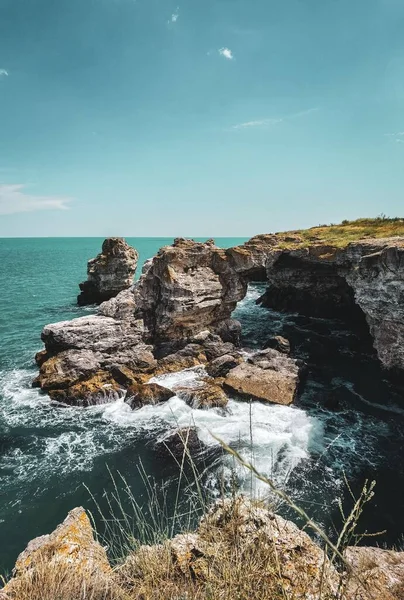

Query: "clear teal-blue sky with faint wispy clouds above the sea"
left=0, top=0, right=404, bottom=237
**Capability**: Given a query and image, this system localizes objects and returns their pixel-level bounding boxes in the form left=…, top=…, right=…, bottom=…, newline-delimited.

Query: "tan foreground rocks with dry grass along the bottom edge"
left=0, top=496, right=404, bottom=600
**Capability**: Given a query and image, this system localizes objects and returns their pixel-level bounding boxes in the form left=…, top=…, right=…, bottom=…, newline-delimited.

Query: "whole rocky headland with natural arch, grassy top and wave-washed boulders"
left=34, top=219, right=404, bottom=408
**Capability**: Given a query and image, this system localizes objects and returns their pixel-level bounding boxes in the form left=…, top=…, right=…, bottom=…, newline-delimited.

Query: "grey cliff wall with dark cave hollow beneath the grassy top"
left=248, top=236, right=404, bottom=372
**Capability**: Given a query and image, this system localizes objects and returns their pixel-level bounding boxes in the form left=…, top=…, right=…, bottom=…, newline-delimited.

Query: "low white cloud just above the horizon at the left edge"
left=0, top=183, right=69, bottom=215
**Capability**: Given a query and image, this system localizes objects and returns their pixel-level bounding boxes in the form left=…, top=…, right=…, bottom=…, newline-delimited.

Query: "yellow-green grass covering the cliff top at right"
left=277, top=216, right=404, bottom=248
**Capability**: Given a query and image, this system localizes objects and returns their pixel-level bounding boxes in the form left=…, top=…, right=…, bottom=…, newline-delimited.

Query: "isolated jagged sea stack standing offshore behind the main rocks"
left=77, top=238, right=139, bottom=306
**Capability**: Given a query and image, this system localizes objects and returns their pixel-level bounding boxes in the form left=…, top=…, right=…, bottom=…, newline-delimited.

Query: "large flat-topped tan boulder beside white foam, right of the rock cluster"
left=225, top=349, right=299, bottom=405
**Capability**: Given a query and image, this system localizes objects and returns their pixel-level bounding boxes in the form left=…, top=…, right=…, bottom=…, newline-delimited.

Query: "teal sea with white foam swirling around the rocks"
left=0, top=238, right=404, bottom=574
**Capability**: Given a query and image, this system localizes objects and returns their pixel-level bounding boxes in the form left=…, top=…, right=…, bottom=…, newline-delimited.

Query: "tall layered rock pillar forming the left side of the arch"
left=135, top=239, right=247, bottom=344
